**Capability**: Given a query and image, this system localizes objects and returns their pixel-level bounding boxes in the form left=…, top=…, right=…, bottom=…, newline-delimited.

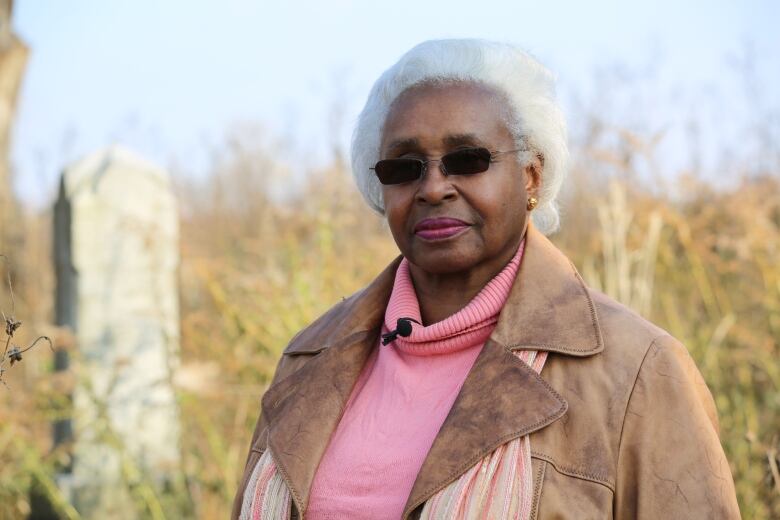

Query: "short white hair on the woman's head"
left=352, top=39, right=569, bottom=234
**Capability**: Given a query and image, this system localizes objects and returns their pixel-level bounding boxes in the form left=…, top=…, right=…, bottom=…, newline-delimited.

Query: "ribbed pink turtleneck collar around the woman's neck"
left=381, top=240, right=525, bottom=356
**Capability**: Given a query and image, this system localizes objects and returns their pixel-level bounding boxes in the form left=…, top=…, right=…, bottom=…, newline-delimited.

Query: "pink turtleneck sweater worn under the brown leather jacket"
left=306, top=244, right=524, bottom=520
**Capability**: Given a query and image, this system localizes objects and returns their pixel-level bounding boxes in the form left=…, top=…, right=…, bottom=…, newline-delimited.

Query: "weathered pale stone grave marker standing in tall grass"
left=54, top=146, right=179, bottom=518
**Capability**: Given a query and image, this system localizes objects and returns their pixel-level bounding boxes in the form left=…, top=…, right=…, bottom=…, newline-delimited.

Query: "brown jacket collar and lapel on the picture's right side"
left=404, top=226, right=604, bottom=518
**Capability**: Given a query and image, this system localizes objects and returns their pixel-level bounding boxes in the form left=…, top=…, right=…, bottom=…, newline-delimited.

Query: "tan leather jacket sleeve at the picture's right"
left=615, top=336, right=740, bottom=520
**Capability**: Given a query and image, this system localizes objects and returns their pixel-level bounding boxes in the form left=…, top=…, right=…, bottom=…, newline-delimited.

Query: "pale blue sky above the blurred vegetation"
left=12, top=0, right=780, bottom=205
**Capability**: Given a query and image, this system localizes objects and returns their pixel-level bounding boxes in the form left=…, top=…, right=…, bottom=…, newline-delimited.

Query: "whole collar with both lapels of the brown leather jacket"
left=262, top=226, right=604, bottom=516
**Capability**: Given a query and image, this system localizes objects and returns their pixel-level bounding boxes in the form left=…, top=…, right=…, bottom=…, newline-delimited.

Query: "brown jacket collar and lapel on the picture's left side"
left=262, top=257, right=401, bottom=511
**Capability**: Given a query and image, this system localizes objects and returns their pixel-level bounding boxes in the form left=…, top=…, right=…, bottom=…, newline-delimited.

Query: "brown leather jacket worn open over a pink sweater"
left=232, top=227, right=739, bottom=519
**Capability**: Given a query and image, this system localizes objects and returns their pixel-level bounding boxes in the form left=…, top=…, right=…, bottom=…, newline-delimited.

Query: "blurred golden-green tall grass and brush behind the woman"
left=0, top=109, right=780, bottom=519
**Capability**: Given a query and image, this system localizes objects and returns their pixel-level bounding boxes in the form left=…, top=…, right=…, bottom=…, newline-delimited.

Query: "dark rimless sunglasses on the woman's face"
left=370, top=148, right=520, bottom=184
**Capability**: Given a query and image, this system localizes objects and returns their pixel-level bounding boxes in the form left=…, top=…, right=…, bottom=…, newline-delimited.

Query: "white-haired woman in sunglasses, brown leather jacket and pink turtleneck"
left=233, top=40, right=739, bottom=520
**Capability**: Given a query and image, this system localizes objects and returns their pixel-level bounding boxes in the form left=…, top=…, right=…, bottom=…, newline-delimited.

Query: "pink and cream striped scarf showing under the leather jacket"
left=239, top=350, right=547, bottom=520
